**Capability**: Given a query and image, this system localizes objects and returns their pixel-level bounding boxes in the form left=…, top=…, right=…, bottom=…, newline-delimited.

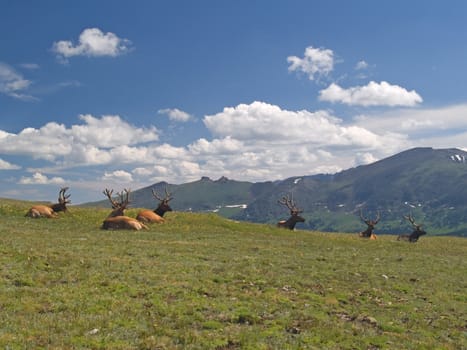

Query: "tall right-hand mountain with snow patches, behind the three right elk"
left=238, top=148, right=467, bottom=235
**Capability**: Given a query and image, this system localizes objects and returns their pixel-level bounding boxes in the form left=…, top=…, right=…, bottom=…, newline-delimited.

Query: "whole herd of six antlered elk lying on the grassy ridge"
left=25, top=187, right=426, bottom=243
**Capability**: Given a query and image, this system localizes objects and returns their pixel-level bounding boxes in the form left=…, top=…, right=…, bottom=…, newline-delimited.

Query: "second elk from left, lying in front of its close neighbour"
left=102, top=189, right=148, bottom=231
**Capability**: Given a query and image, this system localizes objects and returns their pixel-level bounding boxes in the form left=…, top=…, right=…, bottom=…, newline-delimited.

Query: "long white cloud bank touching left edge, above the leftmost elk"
left=0, top=115, right=159, bottom=164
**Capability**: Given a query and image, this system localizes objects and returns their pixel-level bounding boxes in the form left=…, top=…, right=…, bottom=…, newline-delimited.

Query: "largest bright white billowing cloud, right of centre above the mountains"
left=204, top=102, right=377, bottom=146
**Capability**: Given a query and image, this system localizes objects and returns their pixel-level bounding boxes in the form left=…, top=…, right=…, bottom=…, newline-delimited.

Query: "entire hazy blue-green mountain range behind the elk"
left=84, top=148, right=467, bottom=236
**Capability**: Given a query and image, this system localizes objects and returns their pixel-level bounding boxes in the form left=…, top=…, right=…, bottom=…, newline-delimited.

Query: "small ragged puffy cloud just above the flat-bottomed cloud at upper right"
left=287, top=46, right=334, bottom=80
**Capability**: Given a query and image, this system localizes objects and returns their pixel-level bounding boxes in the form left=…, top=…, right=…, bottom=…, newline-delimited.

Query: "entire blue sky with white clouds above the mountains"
left=0, top=0, right=467, bottom=203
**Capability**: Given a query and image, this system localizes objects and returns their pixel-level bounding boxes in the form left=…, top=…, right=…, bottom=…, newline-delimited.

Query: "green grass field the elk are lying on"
left=0, top=200, right=467, bottom=349
